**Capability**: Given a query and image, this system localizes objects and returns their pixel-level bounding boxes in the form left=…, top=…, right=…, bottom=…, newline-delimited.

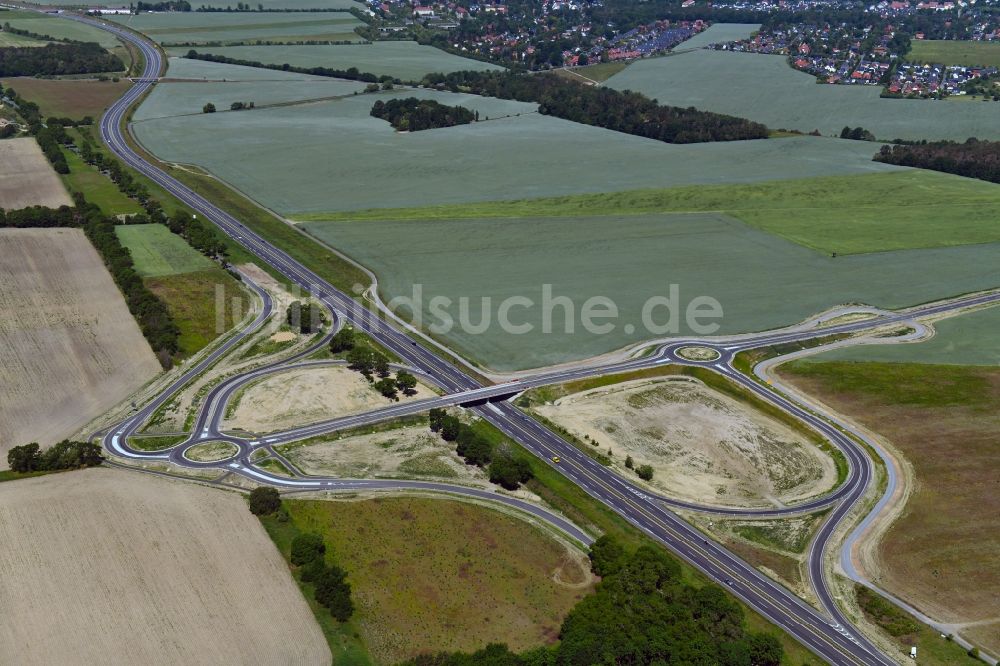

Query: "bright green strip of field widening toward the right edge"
left=295, top=169, right=1000, bottom=255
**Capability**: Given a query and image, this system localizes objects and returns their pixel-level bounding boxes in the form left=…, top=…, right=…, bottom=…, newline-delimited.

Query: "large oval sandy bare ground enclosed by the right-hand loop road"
left=535, top=380, right=837, bottom=506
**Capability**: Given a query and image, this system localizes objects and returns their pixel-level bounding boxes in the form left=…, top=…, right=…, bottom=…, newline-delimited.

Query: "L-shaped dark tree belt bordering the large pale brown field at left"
left=0, top=193, right=180, bottom=367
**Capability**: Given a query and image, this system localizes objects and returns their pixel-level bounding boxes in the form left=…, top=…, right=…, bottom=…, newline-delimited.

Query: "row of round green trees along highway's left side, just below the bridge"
left=429, top=408, right=533, bottom=490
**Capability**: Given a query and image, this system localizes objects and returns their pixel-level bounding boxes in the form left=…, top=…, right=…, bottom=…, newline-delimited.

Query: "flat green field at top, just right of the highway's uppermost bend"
left=111, top=12, right=365, bottom=44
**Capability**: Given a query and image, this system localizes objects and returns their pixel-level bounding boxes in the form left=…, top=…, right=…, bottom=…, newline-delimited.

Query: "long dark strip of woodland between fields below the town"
left=424, top=71, right=768, bottom=143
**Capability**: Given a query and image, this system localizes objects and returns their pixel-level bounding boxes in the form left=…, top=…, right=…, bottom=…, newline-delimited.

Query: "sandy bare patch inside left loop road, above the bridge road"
left=224, top=366, right=434, bottom=432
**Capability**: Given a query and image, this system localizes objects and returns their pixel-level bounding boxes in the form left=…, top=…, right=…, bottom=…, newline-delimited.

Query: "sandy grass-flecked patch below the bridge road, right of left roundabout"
left=281, top=424, right=516, bottom=488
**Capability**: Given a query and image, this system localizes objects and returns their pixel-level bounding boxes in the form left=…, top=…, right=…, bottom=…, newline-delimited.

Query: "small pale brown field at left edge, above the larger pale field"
left=0, top=138, right=73, bottom=210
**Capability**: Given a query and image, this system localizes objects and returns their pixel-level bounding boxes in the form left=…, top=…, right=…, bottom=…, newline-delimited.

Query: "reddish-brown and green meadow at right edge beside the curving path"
left=780, top=358, right=1000, bottom=654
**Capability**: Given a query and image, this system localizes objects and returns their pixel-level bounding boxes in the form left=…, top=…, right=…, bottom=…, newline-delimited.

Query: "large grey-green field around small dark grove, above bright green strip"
left=129, top=77, right=900, bottom=215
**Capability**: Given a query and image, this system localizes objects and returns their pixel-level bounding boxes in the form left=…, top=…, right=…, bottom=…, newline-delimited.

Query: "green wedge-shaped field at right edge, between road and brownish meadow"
left=808, top=300, right=1000, bottom=366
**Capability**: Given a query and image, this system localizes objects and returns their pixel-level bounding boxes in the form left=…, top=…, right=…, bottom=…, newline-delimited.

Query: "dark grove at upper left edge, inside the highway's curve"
left=0, top=42, right=125, bottom=76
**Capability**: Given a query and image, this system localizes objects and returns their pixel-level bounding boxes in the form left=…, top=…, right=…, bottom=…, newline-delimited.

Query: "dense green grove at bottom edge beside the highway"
left=398, top=536, right=784, bottom=666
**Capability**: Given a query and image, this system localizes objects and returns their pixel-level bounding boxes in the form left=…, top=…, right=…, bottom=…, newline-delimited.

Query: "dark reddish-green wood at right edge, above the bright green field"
left=875, top=139, right=1000, bottom=183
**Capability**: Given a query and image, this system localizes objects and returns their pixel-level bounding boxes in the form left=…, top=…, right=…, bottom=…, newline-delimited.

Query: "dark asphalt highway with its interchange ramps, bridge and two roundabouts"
left=76, top=17, right=1000, bottom=664
